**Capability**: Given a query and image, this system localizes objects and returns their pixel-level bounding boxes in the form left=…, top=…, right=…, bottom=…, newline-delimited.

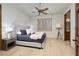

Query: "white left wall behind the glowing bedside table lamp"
left=2, top=4, right=29, bottom=38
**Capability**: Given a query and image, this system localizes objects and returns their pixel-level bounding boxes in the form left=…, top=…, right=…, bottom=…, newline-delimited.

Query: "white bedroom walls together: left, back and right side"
left=2, top=4, right=75, bottom=45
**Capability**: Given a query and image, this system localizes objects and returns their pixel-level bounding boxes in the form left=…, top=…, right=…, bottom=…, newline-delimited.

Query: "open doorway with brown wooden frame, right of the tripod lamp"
left=64, top=10, right=71, bottom=44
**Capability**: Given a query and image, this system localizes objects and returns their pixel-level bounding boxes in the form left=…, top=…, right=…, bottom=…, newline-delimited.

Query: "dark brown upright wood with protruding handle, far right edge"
left=73, top=3, right=79, bottom=56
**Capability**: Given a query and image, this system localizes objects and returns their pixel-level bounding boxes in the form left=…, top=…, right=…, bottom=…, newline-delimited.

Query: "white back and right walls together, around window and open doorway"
left=30, top=3, right=75, bottom=48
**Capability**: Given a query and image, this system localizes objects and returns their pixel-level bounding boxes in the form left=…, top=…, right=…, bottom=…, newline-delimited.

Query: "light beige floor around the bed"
left=0, top=39, right=75, bottom=56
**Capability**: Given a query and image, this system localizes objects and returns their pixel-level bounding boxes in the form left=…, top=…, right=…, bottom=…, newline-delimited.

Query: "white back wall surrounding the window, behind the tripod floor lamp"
left=30, top=13, right=64, bottom=38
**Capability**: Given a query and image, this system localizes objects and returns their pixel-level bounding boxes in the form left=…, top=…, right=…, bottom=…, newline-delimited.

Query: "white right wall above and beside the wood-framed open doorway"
left=63, top=3, right=75, bottom=47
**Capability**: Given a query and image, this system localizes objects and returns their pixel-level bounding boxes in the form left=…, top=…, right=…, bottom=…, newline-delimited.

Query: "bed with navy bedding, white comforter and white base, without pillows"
left=16, top=32, right=46, bottom=49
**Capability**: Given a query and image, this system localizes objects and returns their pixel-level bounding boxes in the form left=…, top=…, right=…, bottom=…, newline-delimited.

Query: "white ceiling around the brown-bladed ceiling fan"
left=10, top=3, right=71, bottom=15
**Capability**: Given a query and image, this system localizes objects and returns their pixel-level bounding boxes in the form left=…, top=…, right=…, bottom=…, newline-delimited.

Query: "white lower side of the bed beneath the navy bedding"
left=16, top=39, right=46, bottom=49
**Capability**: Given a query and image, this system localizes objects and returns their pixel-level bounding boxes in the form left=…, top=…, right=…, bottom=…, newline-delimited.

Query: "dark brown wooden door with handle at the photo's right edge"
left=74, top=4, right=79, bottom=56
